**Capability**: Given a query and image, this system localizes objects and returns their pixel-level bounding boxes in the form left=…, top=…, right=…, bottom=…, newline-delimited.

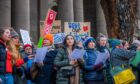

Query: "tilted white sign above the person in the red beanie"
left=20, top=29, right=32, bottom=45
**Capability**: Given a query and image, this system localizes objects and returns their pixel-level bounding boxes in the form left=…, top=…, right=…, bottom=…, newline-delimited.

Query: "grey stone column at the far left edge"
left=0, top=0, right=11, bottom=26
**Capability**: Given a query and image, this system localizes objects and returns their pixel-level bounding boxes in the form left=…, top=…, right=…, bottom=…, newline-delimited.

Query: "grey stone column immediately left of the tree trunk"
left=96, top=0, right=107, bottom=35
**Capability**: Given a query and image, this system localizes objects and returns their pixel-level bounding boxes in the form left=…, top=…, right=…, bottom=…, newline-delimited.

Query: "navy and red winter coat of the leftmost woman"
left=0, top=40, right=28, bottom=74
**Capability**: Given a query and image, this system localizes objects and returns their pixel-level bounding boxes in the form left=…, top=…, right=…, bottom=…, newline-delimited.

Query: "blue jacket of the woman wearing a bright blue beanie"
left=83, top=49, right=104, bottom=80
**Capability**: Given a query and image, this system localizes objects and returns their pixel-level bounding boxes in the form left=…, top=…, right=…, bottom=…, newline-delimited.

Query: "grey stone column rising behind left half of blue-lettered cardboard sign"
left=58, top=0, right=74, bottom=31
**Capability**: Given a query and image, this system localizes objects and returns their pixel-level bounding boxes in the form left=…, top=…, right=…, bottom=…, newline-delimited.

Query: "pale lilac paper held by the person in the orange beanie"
left=34, top=47, right=48, bottom=62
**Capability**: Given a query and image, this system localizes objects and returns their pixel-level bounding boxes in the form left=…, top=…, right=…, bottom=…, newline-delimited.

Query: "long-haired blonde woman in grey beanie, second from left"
left=8, top=29, right=34, bottom=84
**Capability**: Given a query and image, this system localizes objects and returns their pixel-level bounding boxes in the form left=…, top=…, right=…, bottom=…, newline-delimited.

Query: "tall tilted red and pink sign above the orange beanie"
left=44, top=9, right=56, bottom=34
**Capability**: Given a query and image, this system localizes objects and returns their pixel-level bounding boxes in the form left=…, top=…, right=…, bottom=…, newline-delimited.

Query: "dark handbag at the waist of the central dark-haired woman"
left=61, top=66, right=76, bottom=77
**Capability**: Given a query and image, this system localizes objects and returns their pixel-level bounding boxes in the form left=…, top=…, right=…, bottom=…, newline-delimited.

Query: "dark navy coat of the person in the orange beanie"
left=34, top=49, right=57, bottom=84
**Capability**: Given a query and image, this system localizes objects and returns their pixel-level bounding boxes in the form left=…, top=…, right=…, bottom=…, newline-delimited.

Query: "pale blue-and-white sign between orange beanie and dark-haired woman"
left=54, top=33, right=66, bottom=44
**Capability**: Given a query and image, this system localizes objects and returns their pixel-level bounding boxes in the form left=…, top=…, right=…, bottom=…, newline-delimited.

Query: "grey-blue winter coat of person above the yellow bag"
left=111, top=48, right=136, bottom=66
